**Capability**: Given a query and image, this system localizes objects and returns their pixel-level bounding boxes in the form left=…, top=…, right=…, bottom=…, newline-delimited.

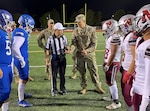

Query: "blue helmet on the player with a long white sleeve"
left=18, top=14, right=35, bottom=34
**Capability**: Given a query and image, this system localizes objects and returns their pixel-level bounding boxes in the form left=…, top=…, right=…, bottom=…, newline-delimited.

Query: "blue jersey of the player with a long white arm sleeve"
left=12, top=28, right=29, bottom=60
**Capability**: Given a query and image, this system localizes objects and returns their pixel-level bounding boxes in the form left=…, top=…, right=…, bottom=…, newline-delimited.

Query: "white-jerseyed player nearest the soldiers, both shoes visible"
left=102, top=19, right=121, bottom=109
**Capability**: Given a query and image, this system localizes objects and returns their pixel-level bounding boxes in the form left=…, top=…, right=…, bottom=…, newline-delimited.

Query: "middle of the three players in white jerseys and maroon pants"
left=118, top=14, right=137, bottom=111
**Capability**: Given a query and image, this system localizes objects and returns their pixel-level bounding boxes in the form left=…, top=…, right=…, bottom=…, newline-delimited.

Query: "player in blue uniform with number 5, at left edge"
left=0, top=9, right=13, bottom=111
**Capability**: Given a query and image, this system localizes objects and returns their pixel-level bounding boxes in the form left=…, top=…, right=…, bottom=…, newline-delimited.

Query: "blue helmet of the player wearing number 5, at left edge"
left=0, top=9, right=13, bottom=31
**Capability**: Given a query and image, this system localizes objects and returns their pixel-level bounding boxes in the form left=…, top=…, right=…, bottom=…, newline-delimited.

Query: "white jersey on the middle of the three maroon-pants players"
left=122, top=32, right=137, bottom=71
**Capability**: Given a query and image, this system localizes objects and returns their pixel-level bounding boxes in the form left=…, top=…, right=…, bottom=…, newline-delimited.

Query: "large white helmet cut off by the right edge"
left=135, top=4, right=150, bottom=33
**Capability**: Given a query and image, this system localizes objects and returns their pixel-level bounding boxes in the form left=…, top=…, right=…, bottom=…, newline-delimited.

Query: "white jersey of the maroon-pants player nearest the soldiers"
left=104, top=34, right=122, bottom=63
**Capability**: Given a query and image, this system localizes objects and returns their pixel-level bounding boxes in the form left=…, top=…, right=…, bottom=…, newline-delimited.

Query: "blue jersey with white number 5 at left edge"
left=0, top=29, right=12, bottom=65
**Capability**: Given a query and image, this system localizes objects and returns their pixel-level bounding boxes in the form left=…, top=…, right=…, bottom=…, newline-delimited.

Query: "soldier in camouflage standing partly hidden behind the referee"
left=37, top=19, right=54, bottom=80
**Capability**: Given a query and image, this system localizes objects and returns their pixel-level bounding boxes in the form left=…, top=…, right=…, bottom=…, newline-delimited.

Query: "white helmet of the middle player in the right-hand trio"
left=118, top=14, right=135, bottom=35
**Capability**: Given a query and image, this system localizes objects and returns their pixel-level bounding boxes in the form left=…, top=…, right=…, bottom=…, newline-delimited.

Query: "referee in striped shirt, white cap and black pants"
left=46, top=22, right=70, bottom=96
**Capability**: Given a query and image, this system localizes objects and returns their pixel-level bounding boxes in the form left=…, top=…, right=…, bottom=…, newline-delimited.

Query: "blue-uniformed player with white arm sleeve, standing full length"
left=12, top=14, right=35, bottom=107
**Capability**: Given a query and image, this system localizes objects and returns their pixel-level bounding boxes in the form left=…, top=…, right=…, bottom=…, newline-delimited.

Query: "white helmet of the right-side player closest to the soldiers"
left=102, top=19, right=119, bottom=36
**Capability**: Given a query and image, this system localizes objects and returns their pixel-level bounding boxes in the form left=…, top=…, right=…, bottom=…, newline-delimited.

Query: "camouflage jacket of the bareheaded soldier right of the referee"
left=72, top=25, right=97, bottom=53
